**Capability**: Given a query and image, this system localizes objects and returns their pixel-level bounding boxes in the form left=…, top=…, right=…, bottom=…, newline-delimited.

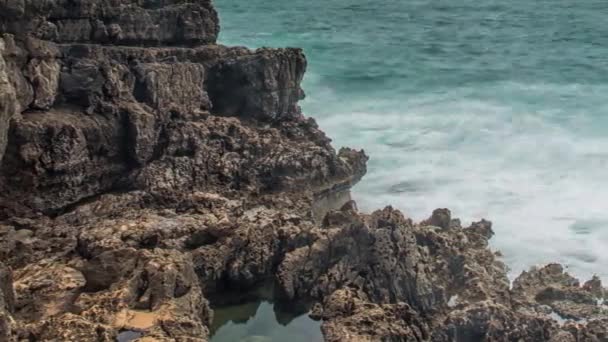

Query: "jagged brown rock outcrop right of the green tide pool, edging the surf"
left=277, top=205, right=606, bottom=342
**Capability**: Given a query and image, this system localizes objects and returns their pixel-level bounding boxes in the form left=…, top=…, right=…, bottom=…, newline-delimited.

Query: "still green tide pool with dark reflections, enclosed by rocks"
left=210, top=285, right=323, bottom=342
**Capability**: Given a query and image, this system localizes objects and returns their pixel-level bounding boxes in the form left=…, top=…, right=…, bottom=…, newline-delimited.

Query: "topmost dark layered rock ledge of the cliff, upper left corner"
left=0, top=0, right=219, bottom=45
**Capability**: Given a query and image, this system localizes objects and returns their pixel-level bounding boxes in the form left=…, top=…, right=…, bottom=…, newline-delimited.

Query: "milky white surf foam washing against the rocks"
left=305, top=83, right=608, bottom=281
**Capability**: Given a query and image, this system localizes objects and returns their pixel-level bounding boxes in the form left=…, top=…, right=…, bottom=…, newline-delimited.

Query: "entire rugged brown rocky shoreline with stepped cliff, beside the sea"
left=0, top=0, right=608, bottom=342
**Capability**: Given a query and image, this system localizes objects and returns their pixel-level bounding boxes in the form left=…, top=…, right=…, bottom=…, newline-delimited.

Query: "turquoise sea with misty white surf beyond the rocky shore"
left=215, top=0, right=608, bottom=281
